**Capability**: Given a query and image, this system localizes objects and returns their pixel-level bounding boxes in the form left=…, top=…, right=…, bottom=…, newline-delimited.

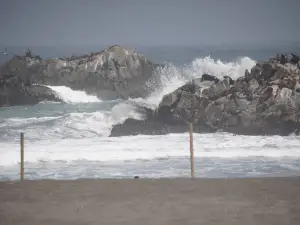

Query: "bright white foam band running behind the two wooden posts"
left=0, top=133, right=300, bottom=166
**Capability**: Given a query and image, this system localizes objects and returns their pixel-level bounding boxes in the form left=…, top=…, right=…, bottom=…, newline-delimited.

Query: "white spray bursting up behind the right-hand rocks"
left=147, top=56, right=256, bottom=105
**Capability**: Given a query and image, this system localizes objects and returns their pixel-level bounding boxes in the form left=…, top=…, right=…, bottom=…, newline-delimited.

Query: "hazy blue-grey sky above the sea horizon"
left=0, top=0, right=300, bottom=46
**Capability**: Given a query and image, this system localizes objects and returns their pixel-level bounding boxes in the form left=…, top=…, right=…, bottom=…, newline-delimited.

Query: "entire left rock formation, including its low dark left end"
left=0, top=45, right=157, bottom=107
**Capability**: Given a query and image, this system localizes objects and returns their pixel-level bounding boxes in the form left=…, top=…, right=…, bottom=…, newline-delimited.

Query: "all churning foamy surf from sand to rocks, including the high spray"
left=0, top=53, right=300, bottom=180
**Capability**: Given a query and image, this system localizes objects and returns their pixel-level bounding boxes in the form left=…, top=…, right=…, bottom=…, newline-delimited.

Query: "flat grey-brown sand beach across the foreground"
left=0, top=177, right=300, bottom=225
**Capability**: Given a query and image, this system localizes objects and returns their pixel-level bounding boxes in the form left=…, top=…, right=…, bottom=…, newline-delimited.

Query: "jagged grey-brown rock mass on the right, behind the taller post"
left=111, top=54, right=300, bottom=136
